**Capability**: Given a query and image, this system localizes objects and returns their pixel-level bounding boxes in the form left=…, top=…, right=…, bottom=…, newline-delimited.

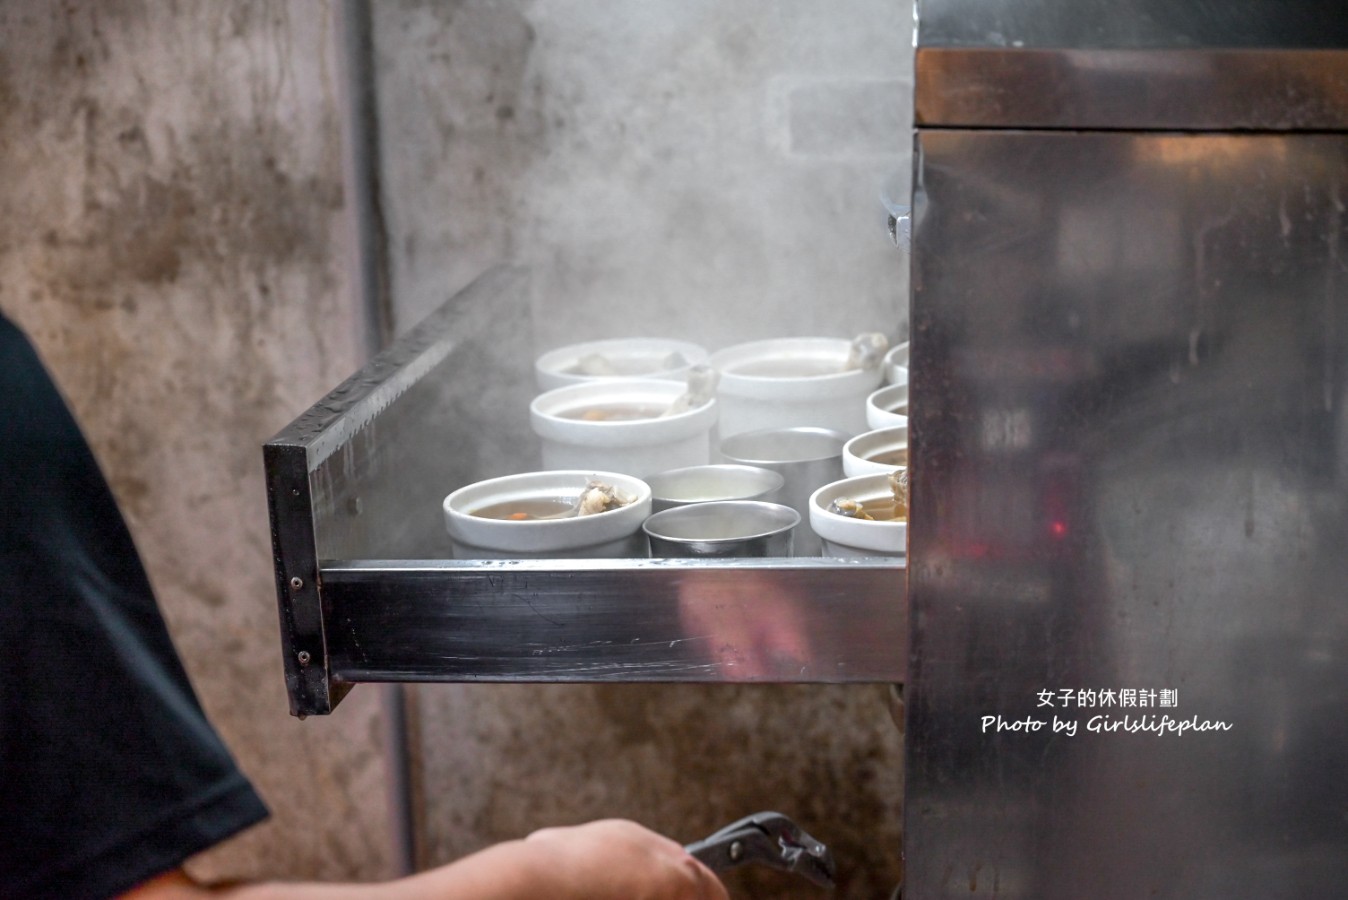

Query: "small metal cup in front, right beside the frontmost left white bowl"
left=642, top=500, right=801, bottom=558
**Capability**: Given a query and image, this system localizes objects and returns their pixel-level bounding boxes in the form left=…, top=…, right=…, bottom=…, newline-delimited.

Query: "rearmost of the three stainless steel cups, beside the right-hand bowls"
left=720, top=427, right=852, bottom=556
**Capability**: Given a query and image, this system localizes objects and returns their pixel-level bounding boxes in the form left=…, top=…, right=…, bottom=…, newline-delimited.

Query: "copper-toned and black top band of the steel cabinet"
left=914, top=0, right=1348, bottom=131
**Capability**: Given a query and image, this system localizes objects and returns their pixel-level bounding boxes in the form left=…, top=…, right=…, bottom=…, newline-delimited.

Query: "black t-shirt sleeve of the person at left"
left=0, top=317, right=267, bottom=899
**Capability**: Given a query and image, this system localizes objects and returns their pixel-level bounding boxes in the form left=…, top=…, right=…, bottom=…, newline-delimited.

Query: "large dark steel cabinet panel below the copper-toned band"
left=903, top=130, right=1348, bottom=900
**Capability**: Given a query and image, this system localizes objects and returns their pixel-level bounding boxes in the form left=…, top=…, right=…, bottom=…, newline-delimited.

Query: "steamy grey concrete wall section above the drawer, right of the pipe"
left=375, top=0, right=913, bottom=350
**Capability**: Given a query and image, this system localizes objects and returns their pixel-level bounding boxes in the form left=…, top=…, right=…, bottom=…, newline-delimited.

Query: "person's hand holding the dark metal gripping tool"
left=524, top=819, right=729, bottom=900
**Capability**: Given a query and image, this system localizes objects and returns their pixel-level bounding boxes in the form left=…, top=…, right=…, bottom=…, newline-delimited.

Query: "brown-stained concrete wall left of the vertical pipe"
left=0, top=0, right=392, bottom=877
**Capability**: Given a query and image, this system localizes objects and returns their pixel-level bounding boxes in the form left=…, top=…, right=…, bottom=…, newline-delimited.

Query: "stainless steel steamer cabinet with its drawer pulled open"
left=264, top=0, right=1348, bottom=899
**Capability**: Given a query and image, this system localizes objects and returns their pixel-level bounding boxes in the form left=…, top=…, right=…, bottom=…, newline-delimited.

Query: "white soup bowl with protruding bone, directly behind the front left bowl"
left=528, top=379, right=717, bottom=478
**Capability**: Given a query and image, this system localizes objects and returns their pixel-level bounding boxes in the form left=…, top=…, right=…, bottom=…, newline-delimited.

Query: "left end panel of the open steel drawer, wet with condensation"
left=263, top=268, right=528, bottom=715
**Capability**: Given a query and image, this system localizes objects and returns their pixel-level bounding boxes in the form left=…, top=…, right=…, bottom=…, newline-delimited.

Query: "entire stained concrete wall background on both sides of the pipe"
left=0, top=0, right=911, bottom=897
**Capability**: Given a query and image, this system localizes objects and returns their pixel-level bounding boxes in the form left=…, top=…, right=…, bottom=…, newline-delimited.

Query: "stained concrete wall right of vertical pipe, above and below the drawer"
left=374, top=0, right=911, bottom=897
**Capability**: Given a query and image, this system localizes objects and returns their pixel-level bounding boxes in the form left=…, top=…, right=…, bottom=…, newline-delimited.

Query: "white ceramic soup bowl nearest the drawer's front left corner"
left=443, top=469, right=651, bottom=559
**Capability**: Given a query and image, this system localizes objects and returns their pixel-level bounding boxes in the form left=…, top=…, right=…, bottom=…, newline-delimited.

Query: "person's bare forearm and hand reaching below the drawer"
left=121, top=819, right=729, bottom=900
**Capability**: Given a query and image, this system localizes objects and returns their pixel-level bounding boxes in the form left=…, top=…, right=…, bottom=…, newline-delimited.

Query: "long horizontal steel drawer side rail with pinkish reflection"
left=324, top=559, right=906, bottom=683
